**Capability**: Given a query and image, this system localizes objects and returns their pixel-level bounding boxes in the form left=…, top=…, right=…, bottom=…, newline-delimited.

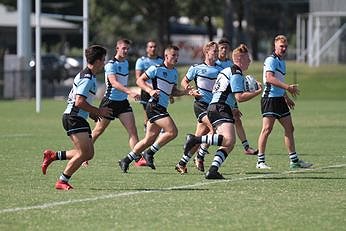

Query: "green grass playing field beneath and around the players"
left=0, top=61, right=346, bottom=231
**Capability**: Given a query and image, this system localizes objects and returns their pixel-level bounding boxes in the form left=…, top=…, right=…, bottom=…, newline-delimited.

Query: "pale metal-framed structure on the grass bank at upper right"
left=296, top=12, right=346, bottom=66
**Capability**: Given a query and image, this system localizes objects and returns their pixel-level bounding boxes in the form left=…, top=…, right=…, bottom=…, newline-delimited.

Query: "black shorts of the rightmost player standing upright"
left=261, top=97, right=291, bottom=119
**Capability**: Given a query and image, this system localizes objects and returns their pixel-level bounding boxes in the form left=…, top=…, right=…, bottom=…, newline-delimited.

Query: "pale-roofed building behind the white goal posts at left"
left=0, top=4, right=82, bottom=98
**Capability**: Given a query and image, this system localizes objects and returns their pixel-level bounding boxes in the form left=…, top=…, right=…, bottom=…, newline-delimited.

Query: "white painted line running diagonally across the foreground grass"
left=0, top=164, right=346, bottom=214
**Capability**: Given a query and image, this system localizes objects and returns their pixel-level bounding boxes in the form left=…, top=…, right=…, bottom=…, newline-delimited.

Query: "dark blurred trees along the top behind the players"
left=0, top=0, right=309, bottom=60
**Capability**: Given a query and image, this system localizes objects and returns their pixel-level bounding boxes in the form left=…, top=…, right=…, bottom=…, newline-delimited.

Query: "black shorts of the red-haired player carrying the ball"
left=207, top=103, right=234, bottom=128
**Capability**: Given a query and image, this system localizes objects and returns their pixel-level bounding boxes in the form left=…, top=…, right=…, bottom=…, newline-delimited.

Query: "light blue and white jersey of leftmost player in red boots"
left=64, top=68, right=97, bottom=119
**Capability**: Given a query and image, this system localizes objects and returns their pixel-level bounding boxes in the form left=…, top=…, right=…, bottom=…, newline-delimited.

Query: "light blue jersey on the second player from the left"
left=104, top=58, right=129, bottom=101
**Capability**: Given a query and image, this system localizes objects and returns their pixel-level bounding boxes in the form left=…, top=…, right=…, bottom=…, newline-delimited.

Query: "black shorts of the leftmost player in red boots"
left=62, top=114, right=91, bottom=138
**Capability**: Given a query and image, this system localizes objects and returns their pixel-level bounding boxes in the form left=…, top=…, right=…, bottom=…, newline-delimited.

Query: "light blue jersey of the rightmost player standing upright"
left=262, top=54, right=286, bottom=97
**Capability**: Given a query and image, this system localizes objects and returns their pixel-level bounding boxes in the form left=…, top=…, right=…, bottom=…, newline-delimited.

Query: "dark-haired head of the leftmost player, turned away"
left=85, top=45, right=107, bottom=73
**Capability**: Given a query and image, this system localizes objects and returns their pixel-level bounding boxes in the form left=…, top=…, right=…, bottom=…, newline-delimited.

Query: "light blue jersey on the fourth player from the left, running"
left=145, top=65, right=178, bottom=108
